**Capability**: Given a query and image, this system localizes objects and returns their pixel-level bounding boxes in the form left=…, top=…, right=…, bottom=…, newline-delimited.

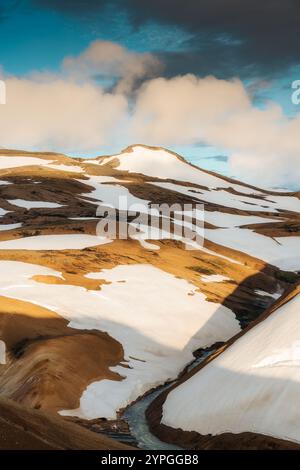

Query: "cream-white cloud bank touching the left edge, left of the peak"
left=0, top=77, right=127, bottom=153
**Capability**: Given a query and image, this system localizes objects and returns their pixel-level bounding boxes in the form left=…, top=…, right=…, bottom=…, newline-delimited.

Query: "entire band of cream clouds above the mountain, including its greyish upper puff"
left=0, top=41, right=300, bottom=187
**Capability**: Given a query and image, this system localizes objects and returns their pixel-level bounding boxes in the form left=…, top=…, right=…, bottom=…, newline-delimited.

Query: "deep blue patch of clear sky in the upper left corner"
left=0, top=0, right=190, bottom=74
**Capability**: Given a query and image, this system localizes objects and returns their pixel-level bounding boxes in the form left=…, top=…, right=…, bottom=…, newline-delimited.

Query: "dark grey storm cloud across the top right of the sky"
left=34, top=0, right=300, bottom=76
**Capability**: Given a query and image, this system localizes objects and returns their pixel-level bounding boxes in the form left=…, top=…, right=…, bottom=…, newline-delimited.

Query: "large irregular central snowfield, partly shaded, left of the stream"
left=0, top=261, right=240, bottom=418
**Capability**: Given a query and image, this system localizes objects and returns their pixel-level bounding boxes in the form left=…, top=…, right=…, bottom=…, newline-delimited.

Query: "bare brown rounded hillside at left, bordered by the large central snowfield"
left=0, top=297, right=123, bottom=411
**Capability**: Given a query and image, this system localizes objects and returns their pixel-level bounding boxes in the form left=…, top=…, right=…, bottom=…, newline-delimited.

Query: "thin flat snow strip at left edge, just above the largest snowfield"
left=0, top=234, right=112, bottom=250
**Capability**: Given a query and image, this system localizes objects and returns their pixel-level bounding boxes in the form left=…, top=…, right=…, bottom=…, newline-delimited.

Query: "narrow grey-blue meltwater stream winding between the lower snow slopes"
left=122, top=349, right=216, bottom=450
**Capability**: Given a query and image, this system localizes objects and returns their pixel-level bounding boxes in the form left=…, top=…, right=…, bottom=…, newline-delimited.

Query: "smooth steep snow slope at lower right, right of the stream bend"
left=162, top=295, right=300, bottom=442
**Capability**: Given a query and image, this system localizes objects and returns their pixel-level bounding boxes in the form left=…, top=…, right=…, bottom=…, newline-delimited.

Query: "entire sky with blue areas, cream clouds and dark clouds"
left=0, top=0, right=300, bottom=190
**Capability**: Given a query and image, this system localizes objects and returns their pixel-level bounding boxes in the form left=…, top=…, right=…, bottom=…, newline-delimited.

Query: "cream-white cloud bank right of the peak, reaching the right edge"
left=132, top=75, right=300, bottom=189
